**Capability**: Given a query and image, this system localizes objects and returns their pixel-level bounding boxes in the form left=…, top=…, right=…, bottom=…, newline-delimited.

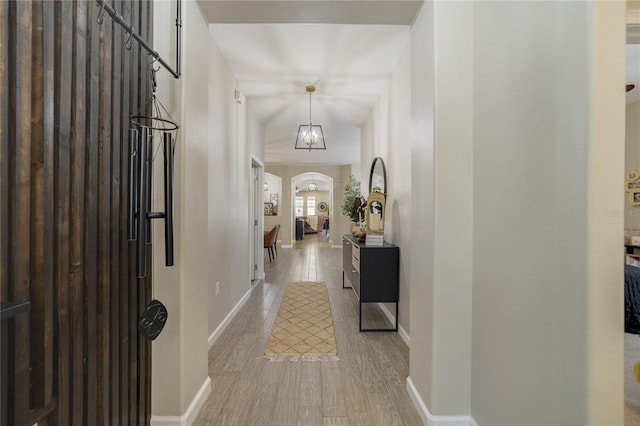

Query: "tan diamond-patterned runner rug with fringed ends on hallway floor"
left=264, top=281, right=338, bottom=361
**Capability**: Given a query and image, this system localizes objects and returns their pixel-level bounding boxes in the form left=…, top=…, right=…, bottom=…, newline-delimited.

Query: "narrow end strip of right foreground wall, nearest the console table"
left=408, top=2, right=436, bottom=412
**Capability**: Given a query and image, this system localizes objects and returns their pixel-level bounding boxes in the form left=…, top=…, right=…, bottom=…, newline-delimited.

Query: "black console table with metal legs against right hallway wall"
left=342, top=235, right=400, bottom=331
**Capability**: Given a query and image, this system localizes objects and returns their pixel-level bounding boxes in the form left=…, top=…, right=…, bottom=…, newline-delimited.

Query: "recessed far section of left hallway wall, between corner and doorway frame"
left=208, top=30, right=254, bottom=335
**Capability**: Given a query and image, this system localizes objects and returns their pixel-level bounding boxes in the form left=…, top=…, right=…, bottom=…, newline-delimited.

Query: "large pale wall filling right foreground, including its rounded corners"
left=409, top=2, right=624, bottom=425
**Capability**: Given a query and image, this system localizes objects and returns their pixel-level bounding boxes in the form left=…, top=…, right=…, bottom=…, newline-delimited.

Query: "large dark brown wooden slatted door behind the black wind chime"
left=0, top=0, right=153, bottom=426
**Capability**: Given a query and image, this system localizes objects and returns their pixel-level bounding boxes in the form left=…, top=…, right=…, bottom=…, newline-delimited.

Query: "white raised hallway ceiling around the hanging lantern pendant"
left=210, top=24, right=410, bottom=164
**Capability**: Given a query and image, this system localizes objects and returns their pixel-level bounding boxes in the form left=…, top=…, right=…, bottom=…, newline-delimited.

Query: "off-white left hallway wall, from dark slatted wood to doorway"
left=151, top=1, right=264, bottom=424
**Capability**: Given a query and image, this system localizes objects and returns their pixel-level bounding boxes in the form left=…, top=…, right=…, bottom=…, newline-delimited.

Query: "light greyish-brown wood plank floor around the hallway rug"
left=194, top=234, right=422, bottom=426
